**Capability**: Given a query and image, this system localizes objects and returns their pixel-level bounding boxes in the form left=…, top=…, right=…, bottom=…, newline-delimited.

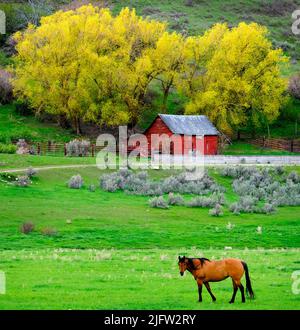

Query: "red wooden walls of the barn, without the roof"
left=145, top=117, right=218, bottom=155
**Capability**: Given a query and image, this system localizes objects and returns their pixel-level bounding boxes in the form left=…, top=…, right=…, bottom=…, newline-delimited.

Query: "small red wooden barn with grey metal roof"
left=144, top=114, right=220, bottom=155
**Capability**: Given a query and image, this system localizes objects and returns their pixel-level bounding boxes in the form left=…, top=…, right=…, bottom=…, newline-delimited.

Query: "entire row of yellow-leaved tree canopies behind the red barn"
left=13, top=5, right=286, bottom=133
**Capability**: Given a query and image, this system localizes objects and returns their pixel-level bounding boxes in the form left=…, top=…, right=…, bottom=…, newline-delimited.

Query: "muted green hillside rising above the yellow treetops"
left=0, top=0, right=300, bottom=75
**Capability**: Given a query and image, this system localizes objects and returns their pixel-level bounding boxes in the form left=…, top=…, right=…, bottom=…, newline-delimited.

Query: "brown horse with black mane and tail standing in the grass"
left=178, top=256, right=254, bottom=304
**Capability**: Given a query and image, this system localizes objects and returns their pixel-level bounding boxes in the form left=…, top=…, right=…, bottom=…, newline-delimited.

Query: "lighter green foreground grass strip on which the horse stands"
left=0, top=249, right=300, bottom=310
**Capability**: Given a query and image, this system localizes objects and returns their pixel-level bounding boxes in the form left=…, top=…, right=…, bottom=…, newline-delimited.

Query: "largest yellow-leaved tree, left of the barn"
left=14, top=5, right=166, bottom=133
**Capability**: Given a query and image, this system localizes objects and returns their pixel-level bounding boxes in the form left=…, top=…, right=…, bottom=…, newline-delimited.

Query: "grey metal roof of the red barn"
left=159, top=114, right=220, bottom=135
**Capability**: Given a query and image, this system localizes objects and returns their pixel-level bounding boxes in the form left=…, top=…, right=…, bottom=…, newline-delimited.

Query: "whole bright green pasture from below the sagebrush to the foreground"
left=0, top=156, right=300, bottom=309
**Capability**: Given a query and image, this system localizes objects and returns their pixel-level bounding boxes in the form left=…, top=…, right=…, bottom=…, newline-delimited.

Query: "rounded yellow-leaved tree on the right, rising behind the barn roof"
left=182, top=23, right=286, bottom=134
